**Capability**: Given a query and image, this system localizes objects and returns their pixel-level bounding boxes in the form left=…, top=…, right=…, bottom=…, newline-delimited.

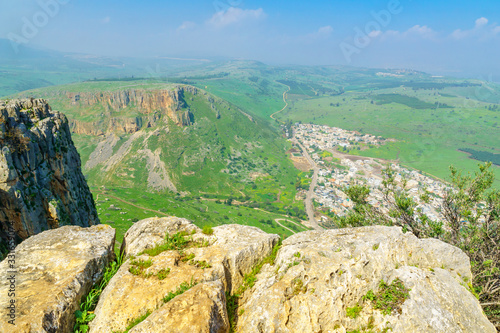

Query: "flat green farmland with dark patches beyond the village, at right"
left=278, top=86, right=500, bottom=186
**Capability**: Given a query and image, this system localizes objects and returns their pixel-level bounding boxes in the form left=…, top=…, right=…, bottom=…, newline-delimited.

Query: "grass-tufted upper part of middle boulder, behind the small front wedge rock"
left=90, top=217, right=279, bottom=333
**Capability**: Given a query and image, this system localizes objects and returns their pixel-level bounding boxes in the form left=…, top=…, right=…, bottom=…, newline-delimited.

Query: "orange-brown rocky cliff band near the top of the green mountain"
left=65, top=86, right=198, bottom=135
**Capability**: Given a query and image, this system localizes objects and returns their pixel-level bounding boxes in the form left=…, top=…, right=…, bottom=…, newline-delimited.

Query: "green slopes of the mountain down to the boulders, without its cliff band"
left=13, top=80, right=305, bottom=246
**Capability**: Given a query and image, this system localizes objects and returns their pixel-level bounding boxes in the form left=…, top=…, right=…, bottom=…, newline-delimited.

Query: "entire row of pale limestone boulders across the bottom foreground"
left=0, top=217, right=495, bottom=333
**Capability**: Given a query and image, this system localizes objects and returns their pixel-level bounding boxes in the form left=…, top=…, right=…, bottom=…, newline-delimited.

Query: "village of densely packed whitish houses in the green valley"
left=292, top=123, right=447, bottom=223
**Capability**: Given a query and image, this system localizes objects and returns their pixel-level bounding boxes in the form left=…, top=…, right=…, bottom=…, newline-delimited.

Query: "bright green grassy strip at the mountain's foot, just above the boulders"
left=90, top=186, right=308, bottom=249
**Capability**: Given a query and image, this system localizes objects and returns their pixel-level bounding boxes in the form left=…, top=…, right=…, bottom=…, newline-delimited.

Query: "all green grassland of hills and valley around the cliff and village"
left=2, top=61, right=500, bottom=240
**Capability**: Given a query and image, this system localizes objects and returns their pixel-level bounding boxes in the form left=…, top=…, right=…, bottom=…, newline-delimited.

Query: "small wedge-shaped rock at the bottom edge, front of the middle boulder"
left=130, top=281, right=229, bottom=333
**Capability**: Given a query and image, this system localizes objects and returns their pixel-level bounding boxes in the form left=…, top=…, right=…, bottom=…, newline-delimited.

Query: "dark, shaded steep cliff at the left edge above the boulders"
left=0, top=99, right=99, bottom=248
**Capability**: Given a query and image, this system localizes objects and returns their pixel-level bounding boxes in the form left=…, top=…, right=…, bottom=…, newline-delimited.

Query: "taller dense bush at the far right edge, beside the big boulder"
left=443, top=163, right=500, bottom=330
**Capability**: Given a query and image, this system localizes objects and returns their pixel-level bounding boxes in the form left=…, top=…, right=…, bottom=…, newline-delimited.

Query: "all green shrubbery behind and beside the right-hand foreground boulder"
left=335, top=163, right=500, bottom=331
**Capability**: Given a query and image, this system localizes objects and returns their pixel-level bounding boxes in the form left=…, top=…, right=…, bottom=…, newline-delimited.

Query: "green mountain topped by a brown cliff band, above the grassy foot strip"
left=15, top=81, right=296, bottom=194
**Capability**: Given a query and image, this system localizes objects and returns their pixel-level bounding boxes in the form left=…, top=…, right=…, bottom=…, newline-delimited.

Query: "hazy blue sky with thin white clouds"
left=0, top=0, right=500, bottom=82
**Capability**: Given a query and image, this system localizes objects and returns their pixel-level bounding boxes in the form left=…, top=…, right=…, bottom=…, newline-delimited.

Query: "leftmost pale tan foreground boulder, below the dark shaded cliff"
left=0, top=225, right=115, bottom=333
